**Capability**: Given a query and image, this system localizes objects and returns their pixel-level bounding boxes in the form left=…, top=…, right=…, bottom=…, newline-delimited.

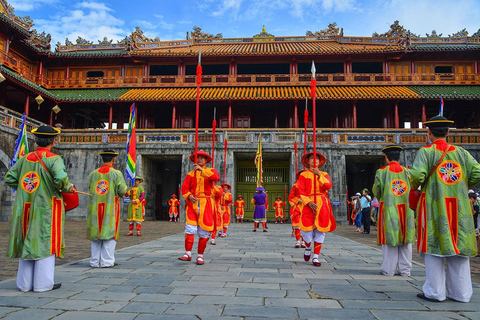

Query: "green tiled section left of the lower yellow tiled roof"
left=49, top=88, right=130, bottom=102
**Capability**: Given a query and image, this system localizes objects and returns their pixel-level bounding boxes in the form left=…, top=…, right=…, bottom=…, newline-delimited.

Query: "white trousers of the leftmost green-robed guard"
left=17, top=254, right=55, bottom=292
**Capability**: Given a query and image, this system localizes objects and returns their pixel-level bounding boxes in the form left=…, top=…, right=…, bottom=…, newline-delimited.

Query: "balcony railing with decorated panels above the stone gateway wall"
left=59, top=128, right=480, bottom=146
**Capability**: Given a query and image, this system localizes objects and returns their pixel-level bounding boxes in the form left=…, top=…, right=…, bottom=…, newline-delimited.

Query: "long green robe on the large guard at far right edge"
left=410, top=139, right=480, bottom=257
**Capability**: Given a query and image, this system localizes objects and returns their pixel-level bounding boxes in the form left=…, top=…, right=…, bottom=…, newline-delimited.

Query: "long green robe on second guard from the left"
left=87, top=164, right=127, bottom=240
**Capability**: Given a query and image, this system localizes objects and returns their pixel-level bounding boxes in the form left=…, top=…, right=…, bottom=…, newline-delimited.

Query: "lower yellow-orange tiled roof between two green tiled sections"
left=120, top=86, right=420, bottom=101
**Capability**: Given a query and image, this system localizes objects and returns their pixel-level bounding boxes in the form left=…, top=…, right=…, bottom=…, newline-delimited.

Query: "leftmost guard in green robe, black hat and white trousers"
left=5, top=126, right=75, bottom=292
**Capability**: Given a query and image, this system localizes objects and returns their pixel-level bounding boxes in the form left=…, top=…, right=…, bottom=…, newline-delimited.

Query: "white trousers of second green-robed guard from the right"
left=381, top=243, right=412, bottom=277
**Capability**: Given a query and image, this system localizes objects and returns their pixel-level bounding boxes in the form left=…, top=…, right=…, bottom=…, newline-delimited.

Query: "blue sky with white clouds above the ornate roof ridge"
left=7, top=0, right=480, bottom=49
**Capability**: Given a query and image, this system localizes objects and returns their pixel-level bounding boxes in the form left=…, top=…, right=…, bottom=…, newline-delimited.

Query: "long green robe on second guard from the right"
left=372, top=161, right=415, bottom=246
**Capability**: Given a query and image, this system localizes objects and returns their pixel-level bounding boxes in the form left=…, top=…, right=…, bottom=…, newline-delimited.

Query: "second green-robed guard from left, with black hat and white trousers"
left=87, top=150, right=127, bottom=268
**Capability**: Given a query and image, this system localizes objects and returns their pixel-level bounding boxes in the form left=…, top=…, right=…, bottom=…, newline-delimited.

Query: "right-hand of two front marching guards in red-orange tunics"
left=298, top=152, right=337, bottom=267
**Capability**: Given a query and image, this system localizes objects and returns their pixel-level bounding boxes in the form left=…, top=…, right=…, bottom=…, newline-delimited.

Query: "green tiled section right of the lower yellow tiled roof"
left=408, top=86, right=480, bottom=99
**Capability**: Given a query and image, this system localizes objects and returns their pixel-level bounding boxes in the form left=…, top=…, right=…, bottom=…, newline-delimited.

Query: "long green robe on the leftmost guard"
left=5, top=148, right=70, bottom=260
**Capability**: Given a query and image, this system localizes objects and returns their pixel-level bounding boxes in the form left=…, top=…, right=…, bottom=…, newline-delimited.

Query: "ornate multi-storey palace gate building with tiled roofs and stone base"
left=0, top=0, right=480, bottom=223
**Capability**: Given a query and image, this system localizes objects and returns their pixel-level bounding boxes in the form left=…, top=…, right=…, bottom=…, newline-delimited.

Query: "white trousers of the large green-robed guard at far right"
left=423, top=254, right=473, bottom=302
